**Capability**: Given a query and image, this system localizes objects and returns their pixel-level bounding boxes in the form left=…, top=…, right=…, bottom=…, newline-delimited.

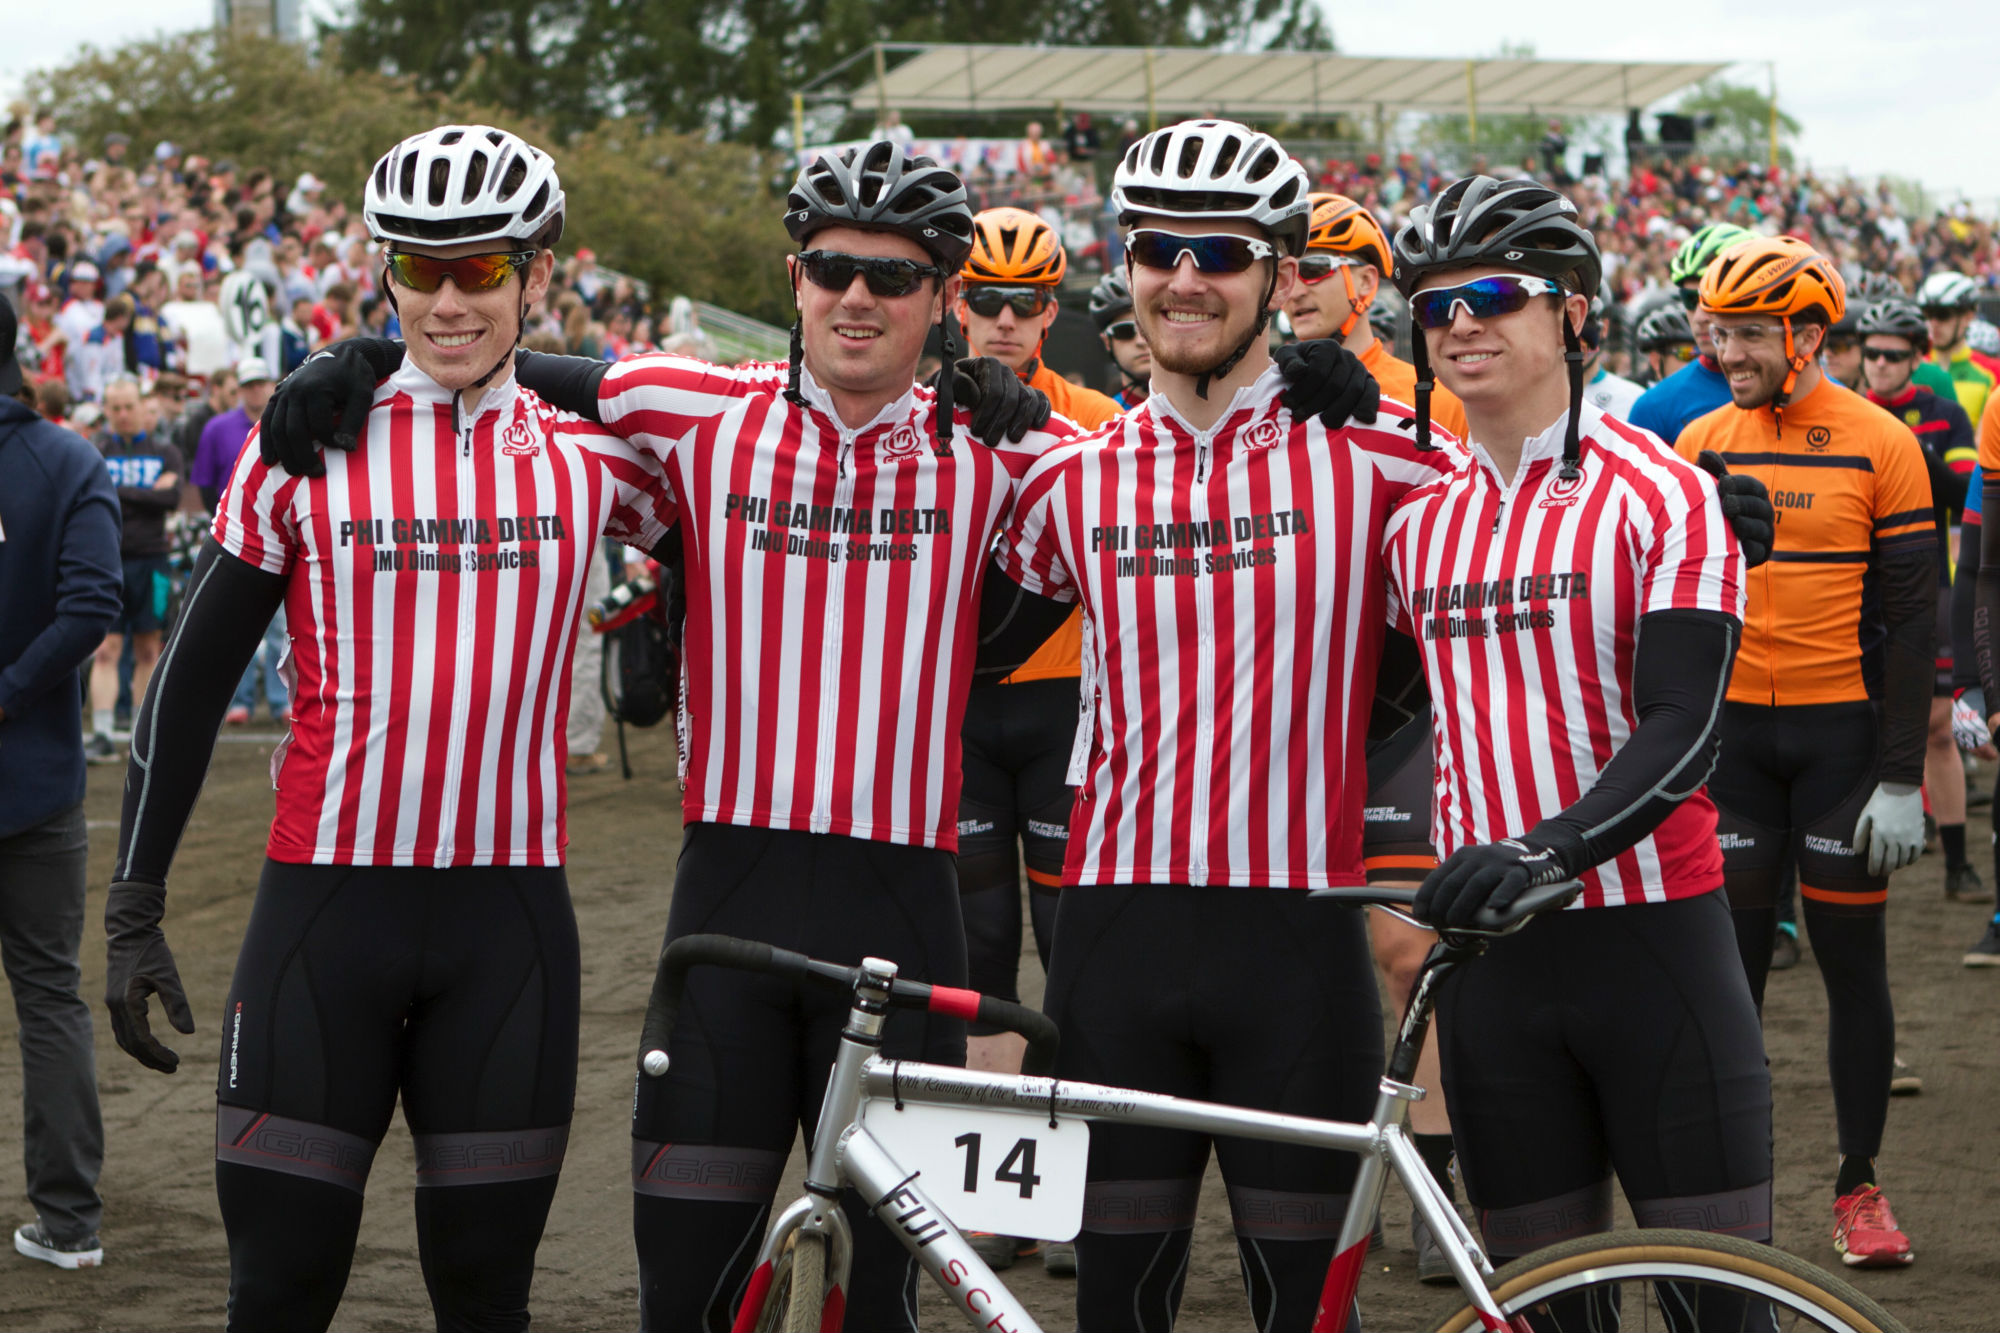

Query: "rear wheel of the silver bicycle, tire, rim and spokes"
left=1438, top=1229, right=1904, bottom=1333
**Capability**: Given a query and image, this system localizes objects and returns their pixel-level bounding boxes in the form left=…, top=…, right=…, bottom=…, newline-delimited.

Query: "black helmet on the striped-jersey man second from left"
left=784, top=138, right=972, bottom=276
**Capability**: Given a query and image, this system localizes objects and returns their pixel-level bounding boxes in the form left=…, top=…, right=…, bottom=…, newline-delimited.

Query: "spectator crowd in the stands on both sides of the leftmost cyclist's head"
left=0, top=108, right=708, bottom=446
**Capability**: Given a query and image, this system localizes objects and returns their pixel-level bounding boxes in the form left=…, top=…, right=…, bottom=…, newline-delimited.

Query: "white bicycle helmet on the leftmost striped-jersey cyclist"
left=362, top=124, right=562, bottom=248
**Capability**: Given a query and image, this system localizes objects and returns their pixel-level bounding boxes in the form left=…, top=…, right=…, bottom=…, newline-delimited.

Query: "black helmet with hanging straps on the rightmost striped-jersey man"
left=1396, top=176, right=1604, bottom=470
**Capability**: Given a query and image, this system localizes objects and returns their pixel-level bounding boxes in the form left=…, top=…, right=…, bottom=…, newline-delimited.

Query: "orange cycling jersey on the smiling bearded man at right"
left=1674, top=376, right=1938, bottom=705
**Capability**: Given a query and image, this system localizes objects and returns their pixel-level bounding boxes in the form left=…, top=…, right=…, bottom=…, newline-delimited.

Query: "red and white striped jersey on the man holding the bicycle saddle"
left=1386, top=404, right=1744, bottom=907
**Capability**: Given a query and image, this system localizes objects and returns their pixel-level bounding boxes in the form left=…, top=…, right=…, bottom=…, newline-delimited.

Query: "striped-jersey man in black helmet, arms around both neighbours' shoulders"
left=266, top=132, right=1366, bottom=1329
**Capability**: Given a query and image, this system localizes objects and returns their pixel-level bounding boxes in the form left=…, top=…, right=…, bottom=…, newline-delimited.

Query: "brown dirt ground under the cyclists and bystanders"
left=0, top=731, right=2000, bottom=1331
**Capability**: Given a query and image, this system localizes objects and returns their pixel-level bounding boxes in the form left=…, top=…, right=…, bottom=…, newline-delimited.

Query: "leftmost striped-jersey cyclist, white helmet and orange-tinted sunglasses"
left=104, top=126, right=670, bottom=1329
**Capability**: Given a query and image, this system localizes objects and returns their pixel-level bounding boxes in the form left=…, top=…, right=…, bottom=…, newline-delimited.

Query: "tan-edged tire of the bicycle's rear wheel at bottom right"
left=1436, top=1229, right=1906, bottom=1333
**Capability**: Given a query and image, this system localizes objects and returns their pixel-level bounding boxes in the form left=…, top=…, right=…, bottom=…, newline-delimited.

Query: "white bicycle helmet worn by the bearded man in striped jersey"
left=1112, top=120, right=1312, bottom=254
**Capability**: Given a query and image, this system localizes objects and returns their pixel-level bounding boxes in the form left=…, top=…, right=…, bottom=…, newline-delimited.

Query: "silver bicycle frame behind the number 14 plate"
left=758, top=959, right=1506, bottom=1333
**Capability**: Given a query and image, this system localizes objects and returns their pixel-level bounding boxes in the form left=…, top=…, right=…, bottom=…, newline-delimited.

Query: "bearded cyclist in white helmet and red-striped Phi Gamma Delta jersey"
left=982, top=120, right=1452, bottom=1333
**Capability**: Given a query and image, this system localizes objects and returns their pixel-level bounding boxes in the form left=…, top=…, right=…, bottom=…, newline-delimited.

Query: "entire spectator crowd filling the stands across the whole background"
left=15, top=108, right=2000, bottom=440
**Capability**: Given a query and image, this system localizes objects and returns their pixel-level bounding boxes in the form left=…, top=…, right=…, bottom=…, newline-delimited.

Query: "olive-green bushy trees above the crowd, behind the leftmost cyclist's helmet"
left=28, top=32, right=792, bottom=324
